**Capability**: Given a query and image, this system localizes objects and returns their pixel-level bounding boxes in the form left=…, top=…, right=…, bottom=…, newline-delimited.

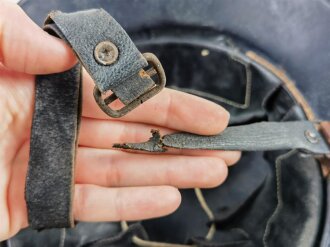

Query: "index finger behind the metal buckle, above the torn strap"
left=83, top=69, right=229, bottom=135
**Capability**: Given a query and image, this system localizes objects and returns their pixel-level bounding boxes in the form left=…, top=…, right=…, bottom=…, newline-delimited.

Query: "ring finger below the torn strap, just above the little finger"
left=76, top=148, right=228, bottom=188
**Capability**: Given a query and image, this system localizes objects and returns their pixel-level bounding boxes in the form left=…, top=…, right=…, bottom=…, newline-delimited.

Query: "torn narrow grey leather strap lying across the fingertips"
left=114, top=121, right=329, bottom=154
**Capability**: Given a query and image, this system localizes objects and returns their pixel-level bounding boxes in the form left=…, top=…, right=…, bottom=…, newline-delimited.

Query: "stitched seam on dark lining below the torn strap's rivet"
left=263, top=150, right=297, bottom=247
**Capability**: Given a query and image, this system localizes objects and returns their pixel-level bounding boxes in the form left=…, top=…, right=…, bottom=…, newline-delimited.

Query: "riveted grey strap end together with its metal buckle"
left=45, top=9, right=166, bottom=117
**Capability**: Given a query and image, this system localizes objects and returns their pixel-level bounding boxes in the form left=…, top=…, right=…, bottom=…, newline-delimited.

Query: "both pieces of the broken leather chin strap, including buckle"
left=25, top=9, right=329, bottom=230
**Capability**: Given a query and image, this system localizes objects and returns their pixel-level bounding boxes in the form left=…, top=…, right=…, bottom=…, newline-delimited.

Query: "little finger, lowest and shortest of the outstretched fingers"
left=73, top=185, right=181, bottom=222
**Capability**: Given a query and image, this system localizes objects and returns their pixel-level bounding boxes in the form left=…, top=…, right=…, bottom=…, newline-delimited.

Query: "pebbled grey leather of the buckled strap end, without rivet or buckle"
left=45, top=9, right=154, bottom=104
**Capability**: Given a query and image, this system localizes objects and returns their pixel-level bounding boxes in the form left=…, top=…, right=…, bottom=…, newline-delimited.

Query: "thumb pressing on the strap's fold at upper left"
left=0, top=0, right=76, bottom=74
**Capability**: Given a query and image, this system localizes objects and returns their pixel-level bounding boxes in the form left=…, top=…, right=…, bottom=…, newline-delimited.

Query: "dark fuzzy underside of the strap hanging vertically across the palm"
left=25, top=65, right=81, bottom=230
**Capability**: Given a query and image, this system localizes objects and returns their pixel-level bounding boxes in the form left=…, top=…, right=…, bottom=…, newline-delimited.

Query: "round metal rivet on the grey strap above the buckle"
left=94, top=41, right=118, bottom=65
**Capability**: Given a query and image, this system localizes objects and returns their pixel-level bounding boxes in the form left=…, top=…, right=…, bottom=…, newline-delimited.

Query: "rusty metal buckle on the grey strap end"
left=94, top=53, right=166, bottom=118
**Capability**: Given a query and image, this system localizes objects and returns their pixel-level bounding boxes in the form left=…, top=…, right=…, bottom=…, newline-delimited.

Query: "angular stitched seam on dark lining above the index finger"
left=169, top=56, right=252, bottom=109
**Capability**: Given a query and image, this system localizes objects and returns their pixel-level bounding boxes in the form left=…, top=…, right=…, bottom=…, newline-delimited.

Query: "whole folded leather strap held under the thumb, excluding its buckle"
left=25, top=9, right=158, bottom=230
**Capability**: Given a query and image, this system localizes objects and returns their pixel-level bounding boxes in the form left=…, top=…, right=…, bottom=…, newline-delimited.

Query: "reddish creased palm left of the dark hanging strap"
left=0, top=66, right=34, bottom=239
